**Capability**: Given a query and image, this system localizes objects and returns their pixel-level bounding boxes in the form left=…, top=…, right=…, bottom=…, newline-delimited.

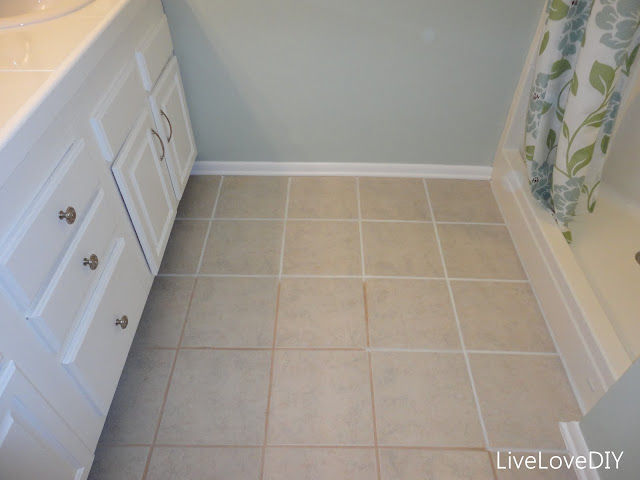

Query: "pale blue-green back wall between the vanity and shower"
left=164, top=0, right=545, bottom=165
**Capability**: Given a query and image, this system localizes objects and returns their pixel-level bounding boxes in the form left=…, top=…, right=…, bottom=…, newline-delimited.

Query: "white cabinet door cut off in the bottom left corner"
left=0, top=355, right=93, bottom=480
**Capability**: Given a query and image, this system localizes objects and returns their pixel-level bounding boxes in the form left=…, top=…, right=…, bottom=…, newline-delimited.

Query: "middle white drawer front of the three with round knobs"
left=29, top=188, right=117, bottom=351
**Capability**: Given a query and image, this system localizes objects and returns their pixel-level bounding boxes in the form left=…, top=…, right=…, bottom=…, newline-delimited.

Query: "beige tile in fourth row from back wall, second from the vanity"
left=158, top=350, right=271, bottom=445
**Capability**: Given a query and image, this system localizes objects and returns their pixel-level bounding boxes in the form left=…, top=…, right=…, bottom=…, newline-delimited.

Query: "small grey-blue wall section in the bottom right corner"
left=580, top=360, right=640, bottom=480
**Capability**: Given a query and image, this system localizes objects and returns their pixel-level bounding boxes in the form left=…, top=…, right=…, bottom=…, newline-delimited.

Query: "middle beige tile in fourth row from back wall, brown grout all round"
left=268, top=351, right=373, bottom=445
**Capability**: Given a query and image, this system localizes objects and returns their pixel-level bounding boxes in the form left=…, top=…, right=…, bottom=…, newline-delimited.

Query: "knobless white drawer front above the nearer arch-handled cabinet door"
left=91, top=62, right=146, bottom=162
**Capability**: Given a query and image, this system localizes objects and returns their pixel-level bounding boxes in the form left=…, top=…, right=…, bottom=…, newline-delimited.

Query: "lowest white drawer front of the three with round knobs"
left=62, top=237, right=150, bottom=415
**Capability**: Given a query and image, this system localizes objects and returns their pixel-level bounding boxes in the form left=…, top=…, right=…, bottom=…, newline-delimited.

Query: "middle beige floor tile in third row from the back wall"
left=276, top=278, right=367, bottom=348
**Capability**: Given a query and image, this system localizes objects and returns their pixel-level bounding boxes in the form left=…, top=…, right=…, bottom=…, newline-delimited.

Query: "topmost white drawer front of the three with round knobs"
left=0, top=141, right=99, bottom=310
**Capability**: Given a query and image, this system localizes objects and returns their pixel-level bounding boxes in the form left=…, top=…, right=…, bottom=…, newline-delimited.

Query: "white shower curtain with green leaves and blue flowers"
left=524, top=0, right=640, bottom=242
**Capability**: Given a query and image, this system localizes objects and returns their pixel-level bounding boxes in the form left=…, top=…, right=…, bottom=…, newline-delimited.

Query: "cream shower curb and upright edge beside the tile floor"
left=491, top=7, right=637, bottom=412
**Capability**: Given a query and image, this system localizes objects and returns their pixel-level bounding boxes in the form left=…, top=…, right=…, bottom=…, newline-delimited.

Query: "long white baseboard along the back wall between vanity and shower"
left=191, top=161, right=492, bottom=180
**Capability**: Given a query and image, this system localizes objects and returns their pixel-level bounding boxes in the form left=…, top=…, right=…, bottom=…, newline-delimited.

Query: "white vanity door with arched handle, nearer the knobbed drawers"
left=112, top=108, right=178, bottom=275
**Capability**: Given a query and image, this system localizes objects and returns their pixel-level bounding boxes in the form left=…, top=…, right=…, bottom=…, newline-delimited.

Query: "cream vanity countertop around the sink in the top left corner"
left=0, top=0, right=132, bottom=149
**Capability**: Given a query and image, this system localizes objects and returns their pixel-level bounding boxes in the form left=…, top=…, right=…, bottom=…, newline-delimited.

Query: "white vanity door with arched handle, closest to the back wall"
left=149, top=57, right=197, bottom=200
